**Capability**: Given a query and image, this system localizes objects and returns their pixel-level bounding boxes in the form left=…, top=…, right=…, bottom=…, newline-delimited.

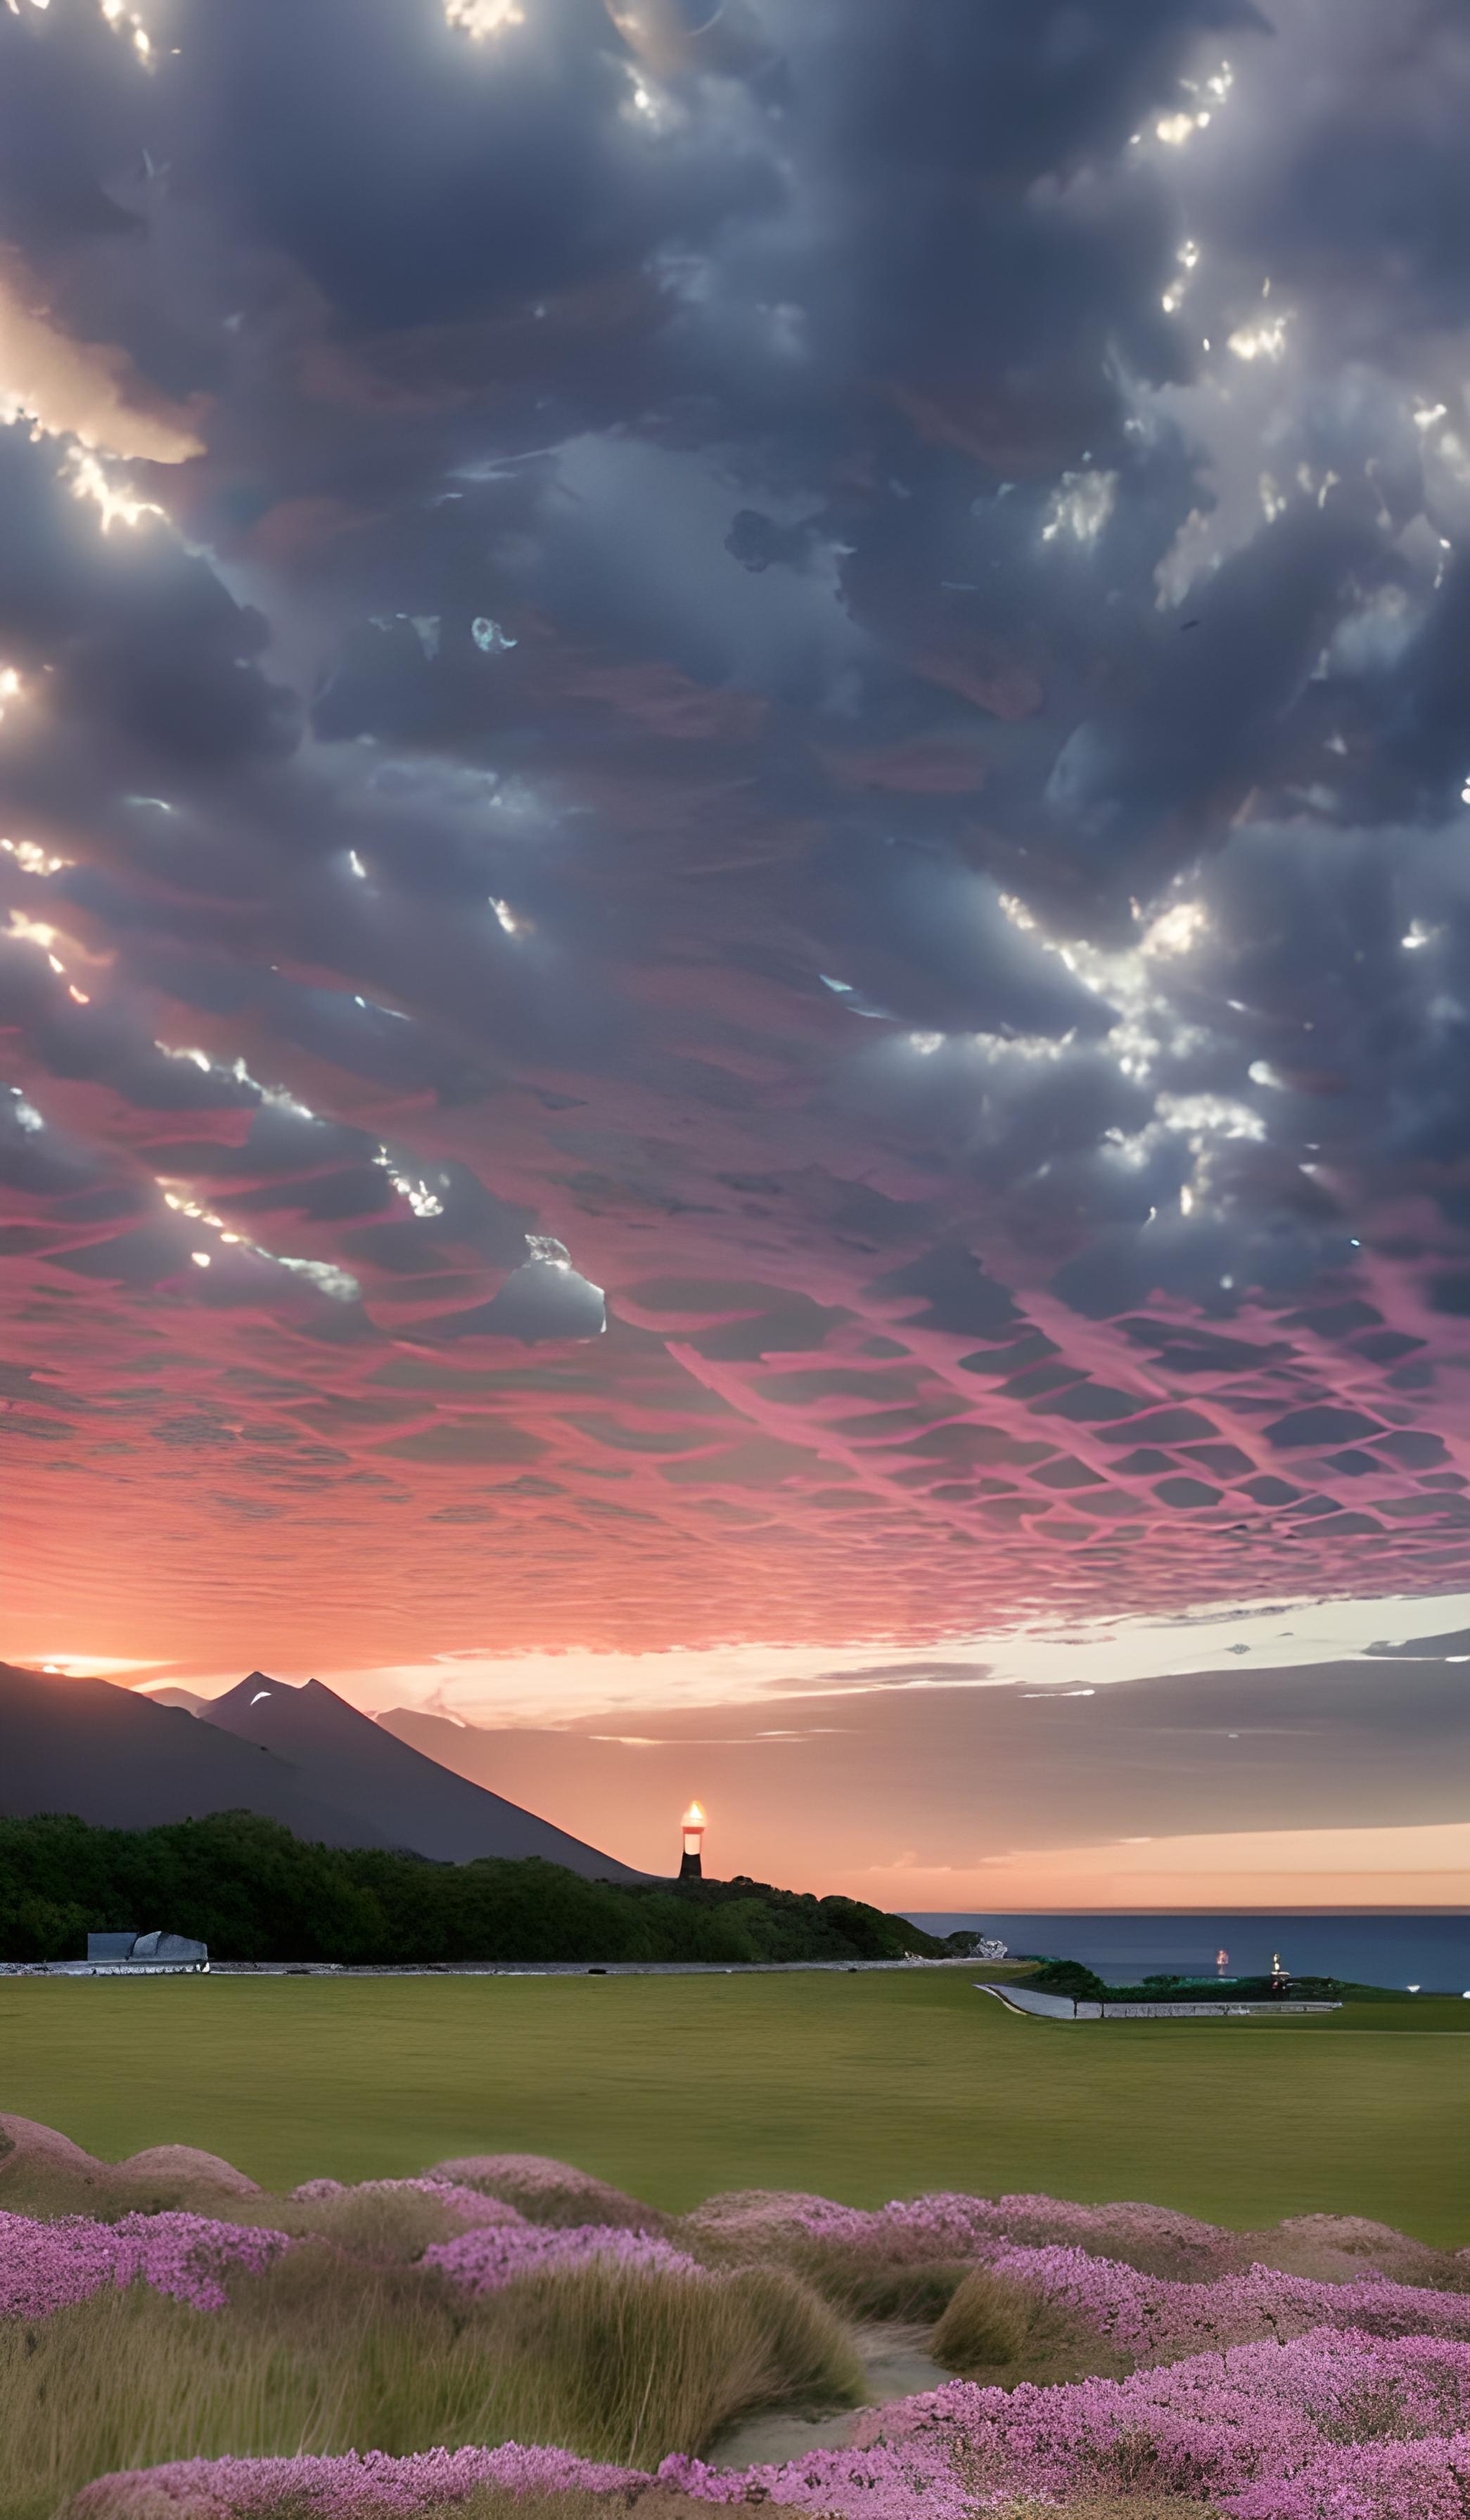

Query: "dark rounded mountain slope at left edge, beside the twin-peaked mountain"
left=0, top=1663, right=401, bottom=1847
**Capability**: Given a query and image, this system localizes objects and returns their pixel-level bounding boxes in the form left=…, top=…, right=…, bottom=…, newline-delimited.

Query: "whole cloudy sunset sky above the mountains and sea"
left=0, top=0, right=1470, bottom=1908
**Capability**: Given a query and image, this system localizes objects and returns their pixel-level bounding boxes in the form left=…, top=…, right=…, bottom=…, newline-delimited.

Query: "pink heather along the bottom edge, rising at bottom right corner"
left=76, top=2329, right=1470, bottom=2520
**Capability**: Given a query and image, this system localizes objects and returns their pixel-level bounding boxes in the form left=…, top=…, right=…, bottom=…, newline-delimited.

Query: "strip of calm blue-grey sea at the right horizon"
left=913, top=1908, right=1470, bottom=1993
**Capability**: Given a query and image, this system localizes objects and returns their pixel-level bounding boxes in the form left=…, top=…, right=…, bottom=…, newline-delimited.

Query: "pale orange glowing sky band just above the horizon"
left=8, top=1633, right=1470, bottom=1915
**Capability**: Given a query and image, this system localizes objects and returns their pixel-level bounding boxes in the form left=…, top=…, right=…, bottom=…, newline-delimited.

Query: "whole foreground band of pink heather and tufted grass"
left=0, top=2119, right=1470, bottom=2520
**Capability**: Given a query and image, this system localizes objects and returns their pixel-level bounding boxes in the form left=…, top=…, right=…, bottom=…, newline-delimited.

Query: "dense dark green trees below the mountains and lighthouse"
left=0, top=1812, right=943, bottom=1966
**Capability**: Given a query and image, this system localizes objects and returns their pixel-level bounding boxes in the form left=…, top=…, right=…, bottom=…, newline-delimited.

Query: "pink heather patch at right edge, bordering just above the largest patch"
left=988, top=2248, right=1470, bottom=2361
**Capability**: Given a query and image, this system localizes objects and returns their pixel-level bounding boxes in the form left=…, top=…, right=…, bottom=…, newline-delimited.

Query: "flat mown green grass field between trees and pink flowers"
left=0, top=1971, right=1470, bottom=2248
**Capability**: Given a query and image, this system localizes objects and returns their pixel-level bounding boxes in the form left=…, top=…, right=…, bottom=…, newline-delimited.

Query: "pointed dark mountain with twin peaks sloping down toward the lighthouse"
left=199, top=1671, right=648, bottom=1882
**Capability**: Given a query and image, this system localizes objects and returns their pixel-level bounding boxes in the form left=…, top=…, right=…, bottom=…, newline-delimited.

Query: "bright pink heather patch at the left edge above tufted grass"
left=0, top=2213, right=290, bottom=2318
